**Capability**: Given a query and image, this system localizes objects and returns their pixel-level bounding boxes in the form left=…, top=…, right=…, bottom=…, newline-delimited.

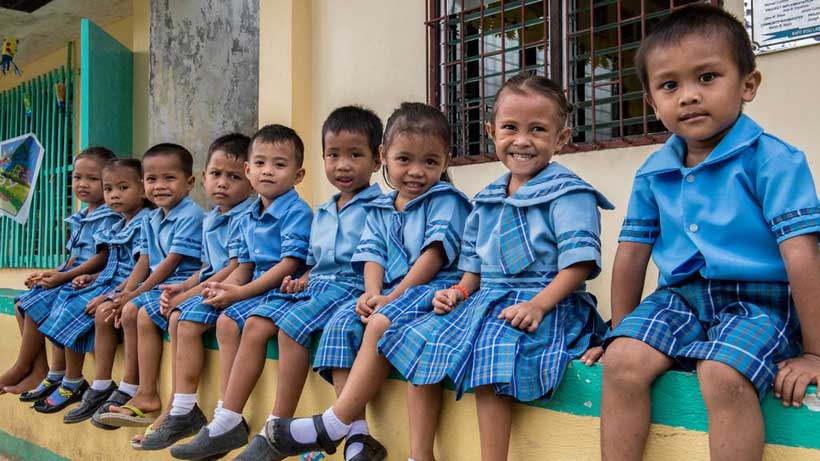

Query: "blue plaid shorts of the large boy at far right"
left=607, top=278, right=802, bottom=398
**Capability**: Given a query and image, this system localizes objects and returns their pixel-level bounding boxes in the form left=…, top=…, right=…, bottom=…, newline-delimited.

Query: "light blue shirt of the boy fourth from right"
left=307, top=184, right=382, bottom=285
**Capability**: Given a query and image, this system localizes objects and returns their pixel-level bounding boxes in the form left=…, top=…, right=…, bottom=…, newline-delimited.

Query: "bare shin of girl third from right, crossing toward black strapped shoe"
left=333, top=314, right=391, bottom=424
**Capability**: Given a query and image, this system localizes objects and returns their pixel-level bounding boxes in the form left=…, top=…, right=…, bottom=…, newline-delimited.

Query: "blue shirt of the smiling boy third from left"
left=140, top=196, right=205, bottom=283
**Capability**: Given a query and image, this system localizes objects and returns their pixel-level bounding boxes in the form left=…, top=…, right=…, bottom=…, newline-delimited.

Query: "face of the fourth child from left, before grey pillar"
left=202, top=150, right=251, bottom=213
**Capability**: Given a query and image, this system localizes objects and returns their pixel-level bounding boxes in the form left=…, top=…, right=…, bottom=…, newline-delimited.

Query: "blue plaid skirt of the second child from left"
left=40, top=282, right=117, bottom=353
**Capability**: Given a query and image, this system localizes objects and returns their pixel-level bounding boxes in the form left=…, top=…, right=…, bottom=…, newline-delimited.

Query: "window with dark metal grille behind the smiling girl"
left=426, top=0, right=717, bottom=165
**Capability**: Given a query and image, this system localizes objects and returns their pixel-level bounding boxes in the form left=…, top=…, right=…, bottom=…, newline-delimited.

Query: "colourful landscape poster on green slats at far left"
left=0, top=133, right=45, bottom=224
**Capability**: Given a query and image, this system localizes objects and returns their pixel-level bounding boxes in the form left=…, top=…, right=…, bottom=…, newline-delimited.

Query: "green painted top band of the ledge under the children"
left=0, top=289, right=820, bottom=449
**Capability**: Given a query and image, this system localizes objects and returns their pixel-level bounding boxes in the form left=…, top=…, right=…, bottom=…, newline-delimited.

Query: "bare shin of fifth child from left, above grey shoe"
left=223, top=316, right=278, bottom=416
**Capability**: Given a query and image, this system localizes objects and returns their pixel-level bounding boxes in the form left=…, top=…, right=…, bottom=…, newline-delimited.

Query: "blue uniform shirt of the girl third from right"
left=352, top=181, right=472, bottom=288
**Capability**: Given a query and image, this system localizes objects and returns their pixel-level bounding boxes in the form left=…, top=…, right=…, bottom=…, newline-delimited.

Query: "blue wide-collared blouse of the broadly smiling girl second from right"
left=458, top=162, right=614, bottom=282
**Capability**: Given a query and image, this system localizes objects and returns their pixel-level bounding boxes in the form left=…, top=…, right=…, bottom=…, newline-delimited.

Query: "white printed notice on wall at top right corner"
left=744, top=0, right=820, bottom=54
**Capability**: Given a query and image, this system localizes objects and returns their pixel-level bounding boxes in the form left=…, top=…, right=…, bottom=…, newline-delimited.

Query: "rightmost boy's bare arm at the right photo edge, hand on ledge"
left=774, top=234, right=820, bottom=407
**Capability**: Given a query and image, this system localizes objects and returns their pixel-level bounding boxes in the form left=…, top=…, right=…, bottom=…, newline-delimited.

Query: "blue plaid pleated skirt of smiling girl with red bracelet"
left=379, top=288, right=606, bottom=401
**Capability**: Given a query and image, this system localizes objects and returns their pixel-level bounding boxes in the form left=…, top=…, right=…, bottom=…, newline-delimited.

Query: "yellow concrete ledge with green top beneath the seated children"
left=0, top=289, right=820, bottom=459
